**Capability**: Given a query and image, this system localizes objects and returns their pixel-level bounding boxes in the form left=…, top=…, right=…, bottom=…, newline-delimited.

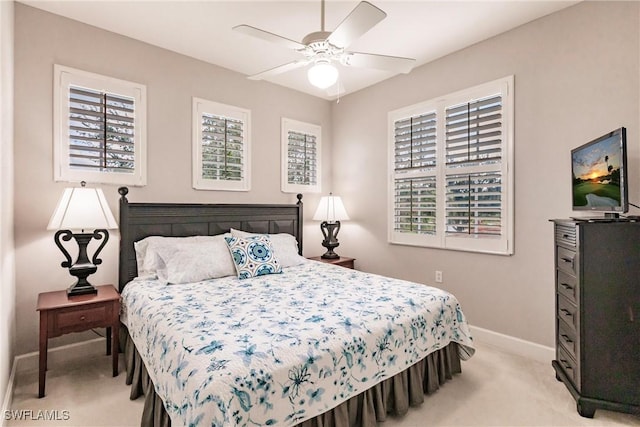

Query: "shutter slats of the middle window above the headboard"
left=201, top=113, right=244, bottom=181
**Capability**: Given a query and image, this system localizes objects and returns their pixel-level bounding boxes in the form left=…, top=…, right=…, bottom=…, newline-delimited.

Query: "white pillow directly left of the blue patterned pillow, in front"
left=157, top=239, right=236, bottom=284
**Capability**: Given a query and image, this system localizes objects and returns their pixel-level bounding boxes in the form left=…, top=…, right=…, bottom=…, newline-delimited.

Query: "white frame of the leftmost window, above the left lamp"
left=53, top=64, right=147, bottom=186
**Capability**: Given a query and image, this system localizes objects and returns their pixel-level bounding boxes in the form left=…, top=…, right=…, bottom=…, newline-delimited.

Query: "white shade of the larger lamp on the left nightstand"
left=47, top=187, right=118, bottom=230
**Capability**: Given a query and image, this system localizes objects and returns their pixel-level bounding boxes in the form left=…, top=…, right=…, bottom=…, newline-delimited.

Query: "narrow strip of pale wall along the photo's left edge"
left=0, top=2, right=16, bottom=409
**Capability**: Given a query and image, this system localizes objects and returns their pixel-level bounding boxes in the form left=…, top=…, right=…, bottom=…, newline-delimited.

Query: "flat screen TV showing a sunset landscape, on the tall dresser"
left=571, top=127, right=629, bottom=218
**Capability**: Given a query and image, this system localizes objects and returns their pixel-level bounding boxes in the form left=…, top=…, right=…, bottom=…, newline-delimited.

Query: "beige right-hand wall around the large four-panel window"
left=332, top=2, right=640, bottom=346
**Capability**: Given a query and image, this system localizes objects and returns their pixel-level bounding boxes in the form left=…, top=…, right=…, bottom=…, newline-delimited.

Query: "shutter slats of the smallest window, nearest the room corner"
left=287, top=130, right=318, bottom=185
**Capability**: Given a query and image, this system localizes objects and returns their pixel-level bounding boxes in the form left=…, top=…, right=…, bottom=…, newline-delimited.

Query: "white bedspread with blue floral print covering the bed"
left=122, top=261, right=474, bottom=426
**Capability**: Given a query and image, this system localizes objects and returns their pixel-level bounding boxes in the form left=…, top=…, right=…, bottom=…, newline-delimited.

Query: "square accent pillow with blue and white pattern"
left=224, top=235, right=282, bottom=279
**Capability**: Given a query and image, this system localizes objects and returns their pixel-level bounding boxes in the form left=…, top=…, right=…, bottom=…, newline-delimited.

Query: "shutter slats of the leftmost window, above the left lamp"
left=68, top=85, right=136, bottom=174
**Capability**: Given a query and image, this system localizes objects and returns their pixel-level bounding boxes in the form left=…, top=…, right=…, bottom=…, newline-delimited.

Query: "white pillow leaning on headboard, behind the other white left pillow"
left=133, top=234, right=229, bottom=279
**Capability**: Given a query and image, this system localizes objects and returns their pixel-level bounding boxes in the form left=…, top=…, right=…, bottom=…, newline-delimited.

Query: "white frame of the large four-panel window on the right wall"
left=387, top=75, right=515, bottom=255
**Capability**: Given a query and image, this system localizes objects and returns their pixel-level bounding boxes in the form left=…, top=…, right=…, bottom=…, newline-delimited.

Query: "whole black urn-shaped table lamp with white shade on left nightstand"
left=47, top=181, right=118, bottom=297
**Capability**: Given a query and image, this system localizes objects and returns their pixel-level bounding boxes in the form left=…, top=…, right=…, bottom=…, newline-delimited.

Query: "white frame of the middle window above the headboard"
left=192, top=97, right=251, bottom=191
